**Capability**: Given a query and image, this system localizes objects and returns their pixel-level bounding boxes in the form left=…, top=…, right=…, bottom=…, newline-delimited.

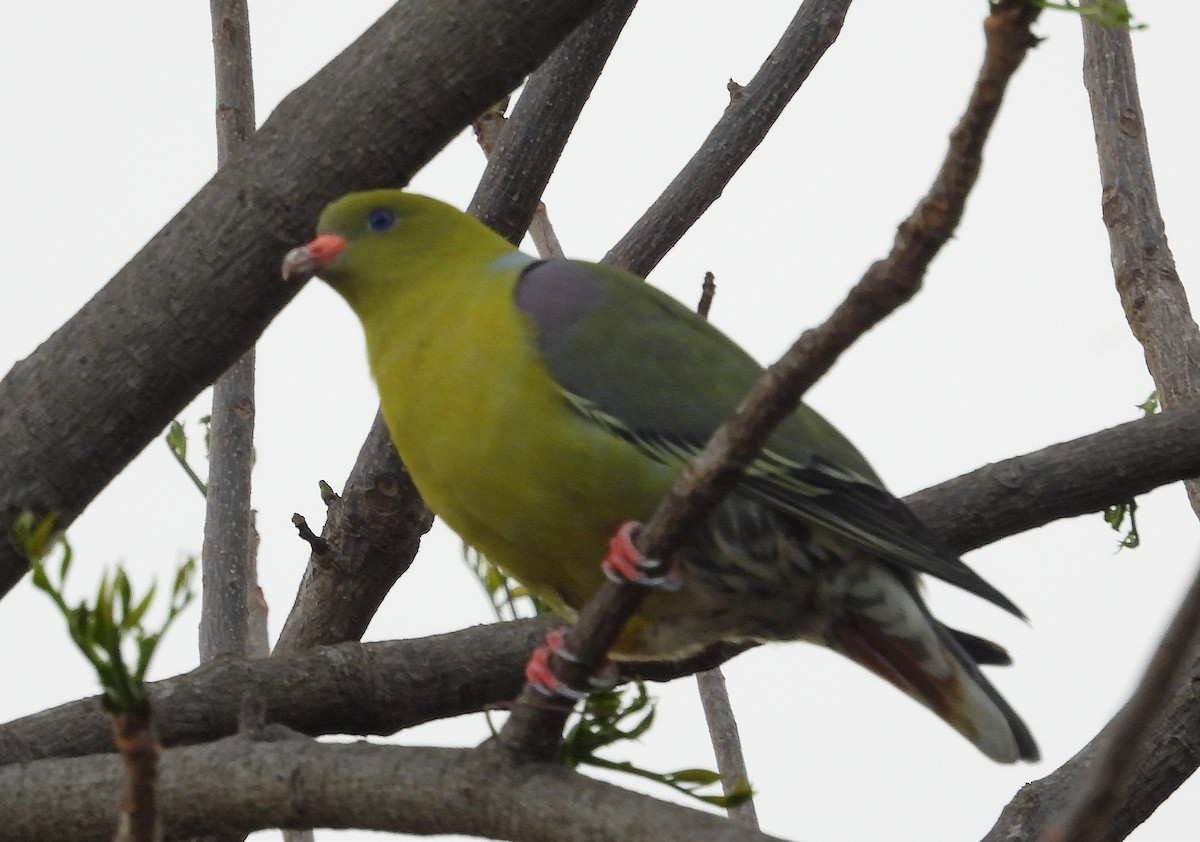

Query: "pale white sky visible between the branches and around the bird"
left=0, top=0, right=1200, bottom=842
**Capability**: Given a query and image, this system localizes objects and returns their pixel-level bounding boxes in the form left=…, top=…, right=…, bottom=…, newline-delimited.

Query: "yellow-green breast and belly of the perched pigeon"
left=366, top=260, right=674, bottom=609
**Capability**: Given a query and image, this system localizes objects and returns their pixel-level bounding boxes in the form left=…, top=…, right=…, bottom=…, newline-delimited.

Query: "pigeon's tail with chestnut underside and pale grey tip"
left=828, top=564, right=1038, bottom=763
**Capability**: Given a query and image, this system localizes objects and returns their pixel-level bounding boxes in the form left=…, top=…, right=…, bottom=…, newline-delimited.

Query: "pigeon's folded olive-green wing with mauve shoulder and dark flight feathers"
left=514, top=260, right=1024, bottom=617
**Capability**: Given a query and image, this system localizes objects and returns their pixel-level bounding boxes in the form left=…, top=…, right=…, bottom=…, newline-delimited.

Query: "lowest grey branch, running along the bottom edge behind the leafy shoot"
left=0, top=729, right=792, bottom=842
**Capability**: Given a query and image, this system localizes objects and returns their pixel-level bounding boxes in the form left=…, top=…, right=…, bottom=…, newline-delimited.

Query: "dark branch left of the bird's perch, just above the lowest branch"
left=0, top=618, right=557, bottom=765
